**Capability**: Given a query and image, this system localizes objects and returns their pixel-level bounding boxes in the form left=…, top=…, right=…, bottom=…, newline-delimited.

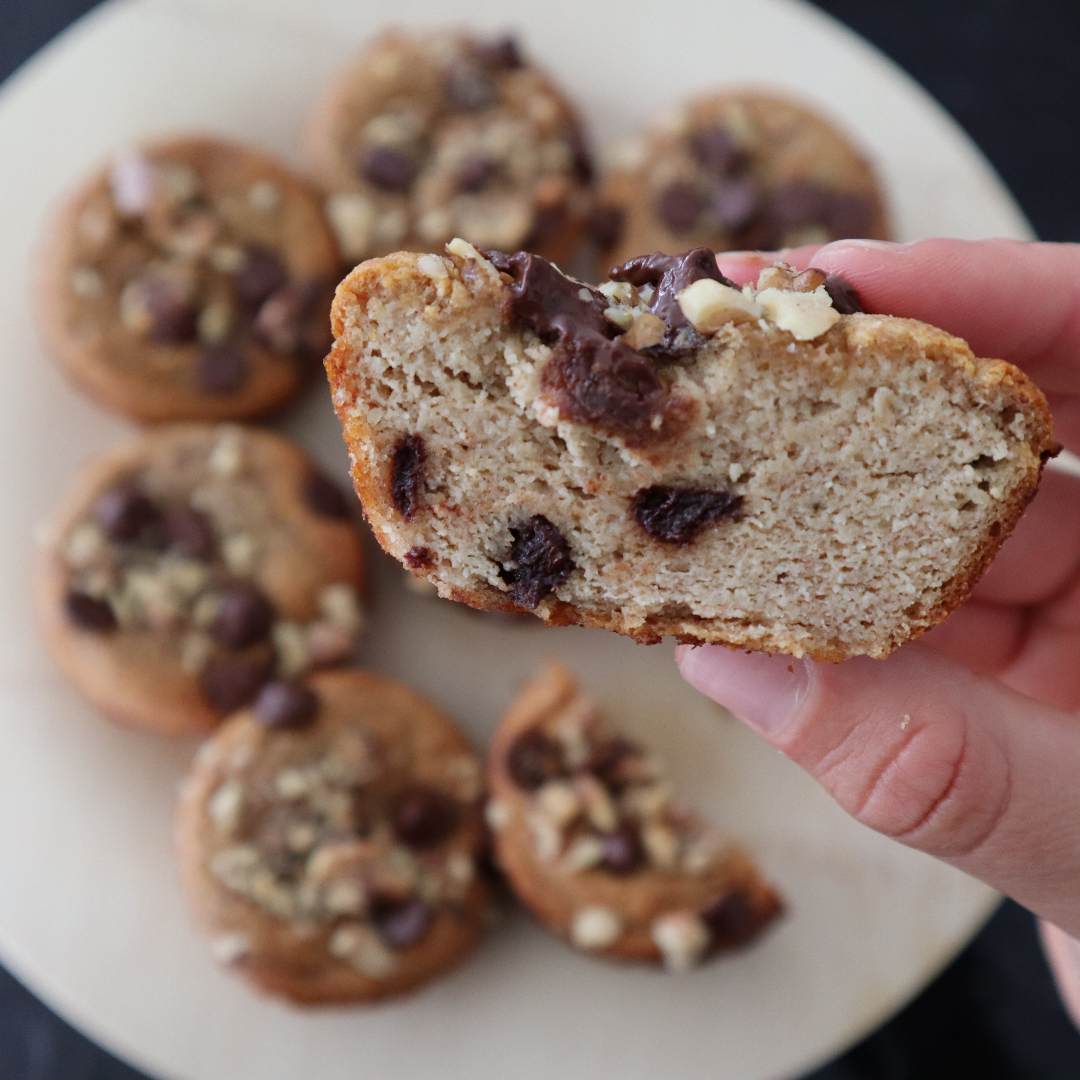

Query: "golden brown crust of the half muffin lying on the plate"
left=488, top=662, right=782, bottom=963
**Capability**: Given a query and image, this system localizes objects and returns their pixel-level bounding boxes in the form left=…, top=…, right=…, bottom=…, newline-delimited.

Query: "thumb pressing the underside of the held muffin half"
left=676, top=645, right=1080, bottom=937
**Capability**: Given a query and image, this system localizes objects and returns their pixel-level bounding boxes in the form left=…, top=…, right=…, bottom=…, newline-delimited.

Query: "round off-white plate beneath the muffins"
left=0, top=0, right=1029, bottom=1080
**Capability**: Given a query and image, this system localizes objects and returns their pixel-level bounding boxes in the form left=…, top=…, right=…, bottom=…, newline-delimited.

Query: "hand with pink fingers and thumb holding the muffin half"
left=676, top=240, right=1080, bottom=937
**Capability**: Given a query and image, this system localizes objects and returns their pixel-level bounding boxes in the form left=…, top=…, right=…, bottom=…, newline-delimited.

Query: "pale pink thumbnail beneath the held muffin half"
left=675, top=645, right=812, bottom=739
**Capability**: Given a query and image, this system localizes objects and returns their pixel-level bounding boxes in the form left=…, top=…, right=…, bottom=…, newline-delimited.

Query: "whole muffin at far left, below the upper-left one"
left=35, top=423, right=363, bottom=734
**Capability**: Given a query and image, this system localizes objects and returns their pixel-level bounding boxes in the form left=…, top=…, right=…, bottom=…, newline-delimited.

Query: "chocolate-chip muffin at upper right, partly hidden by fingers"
left=589, top=90, right=889, bottom=270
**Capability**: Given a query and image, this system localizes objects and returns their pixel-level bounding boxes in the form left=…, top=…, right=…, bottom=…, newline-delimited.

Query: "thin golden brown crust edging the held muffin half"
left=326, top=253, right=1056, bottom=662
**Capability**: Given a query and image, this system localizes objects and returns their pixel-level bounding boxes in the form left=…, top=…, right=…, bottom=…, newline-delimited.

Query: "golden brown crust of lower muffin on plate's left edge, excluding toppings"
left=32, top=423, right=364, bottom=735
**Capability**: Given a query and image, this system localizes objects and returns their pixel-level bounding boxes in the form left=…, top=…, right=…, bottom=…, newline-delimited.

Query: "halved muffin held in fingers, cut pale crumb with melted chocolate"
left=326, top=241, right=1055, bottom=660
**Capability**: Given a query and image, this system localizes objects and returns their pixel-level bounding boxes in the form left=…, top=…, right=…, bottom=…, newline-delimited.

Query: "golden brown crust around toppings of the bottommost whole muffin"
left=176, top=671, right=488, bottom=1005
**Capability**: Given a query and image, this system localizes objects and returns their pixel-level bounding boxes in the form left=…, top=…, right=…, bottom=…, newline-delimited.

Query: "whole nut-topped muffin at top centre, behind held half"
left=307, top=30, right=593, bottom=265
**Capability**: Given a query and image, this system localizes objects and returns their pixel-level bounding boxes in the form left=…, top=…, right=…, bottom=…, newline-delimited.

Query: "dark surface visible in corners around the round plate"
left=0, top=0, right=1080, bottom=1080
